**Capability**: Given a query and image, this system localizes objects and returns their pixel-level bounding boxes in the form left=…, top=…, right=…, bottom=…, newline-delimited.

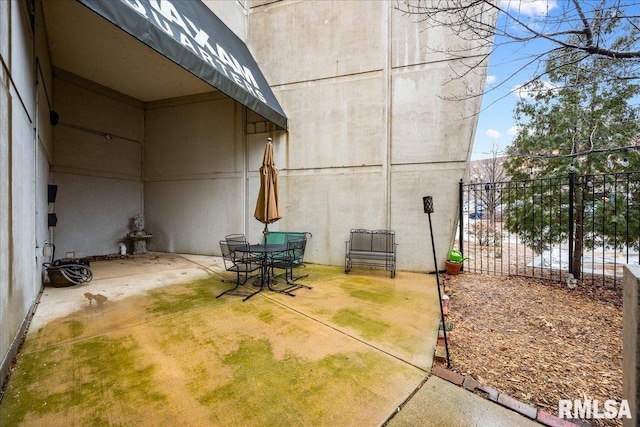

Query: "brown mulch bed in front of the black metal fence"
left=443, top=273, right=622, bottom=426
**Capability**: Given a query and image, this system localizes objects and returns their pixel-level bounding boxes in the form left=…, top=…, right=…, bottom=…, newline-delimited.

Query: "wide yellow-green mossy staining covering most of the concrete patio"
left=0, top=266, right=436, bottom=426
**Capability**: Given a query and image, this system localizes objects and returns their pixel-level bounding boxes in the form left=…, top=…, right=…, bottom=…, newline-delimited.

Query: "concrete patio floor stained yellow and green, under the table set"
left=0, top=253, right=537, bottom=426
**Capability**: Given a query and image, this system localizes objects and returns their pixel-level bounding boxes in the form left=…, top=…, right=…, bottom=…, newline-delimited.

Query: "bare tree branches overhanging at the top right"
left=394, top=0, right=640, bottom=96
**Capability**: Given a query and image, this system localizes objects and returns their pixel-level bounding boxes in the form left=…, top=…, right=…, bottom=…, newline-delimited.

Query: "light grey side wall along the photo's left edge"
left=0, top=0, right=52, bottom=386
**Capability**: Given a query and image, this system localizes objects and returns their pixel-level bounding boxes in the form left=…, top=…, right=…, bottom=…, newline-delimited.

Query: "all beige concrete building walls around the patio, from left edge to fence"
left=0, top=0, right=484, bottom=384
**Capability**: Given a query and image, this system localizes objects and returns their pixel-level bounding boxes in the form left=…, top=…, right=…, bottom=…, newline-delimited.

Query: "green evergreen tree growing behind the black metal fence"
left=503, top=45, right=640, bottom=277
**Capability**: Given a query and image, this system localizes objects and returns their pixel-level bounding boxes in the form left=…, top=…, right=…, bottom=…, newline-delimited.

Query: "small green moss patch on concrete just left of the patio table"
left=148, top=279, right=220, bottom=315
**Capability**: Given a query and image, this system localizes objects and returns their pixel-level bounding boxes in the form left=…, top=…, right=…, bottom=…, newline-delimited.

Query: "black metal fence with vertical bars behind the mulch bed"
left=457, top=172, right=640, bottom=287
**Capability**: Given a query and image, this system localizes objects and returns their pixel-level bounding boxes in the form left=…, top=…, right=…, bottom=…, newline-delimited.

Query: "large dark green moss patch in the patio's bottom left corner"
left=0, top=337, right=167, bottom=426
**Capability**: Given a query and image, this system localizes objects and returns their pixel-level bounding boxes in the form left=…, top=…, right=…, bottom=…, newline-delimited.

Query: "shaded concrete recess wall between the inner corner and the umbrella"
left=145, top=93, right=246, bottom=254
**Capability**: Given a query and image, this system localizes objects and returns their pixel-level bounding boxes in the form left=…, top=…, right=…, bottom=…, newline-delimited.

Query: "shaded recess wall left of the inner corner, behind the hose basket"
left=53, top=74, right=144, bottom=258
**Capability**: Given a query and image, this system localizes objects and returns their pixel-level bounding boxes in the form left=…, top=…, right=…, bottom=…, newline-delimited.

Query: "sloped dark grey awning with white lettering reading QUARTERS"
left=78, top=0, right=287, bottom=130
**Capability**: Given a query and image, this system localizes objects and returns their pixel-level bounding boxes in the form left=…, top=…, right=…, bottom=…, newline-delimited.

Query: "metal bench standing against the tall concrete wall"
left=344, top=228, right=397, bottom=278
